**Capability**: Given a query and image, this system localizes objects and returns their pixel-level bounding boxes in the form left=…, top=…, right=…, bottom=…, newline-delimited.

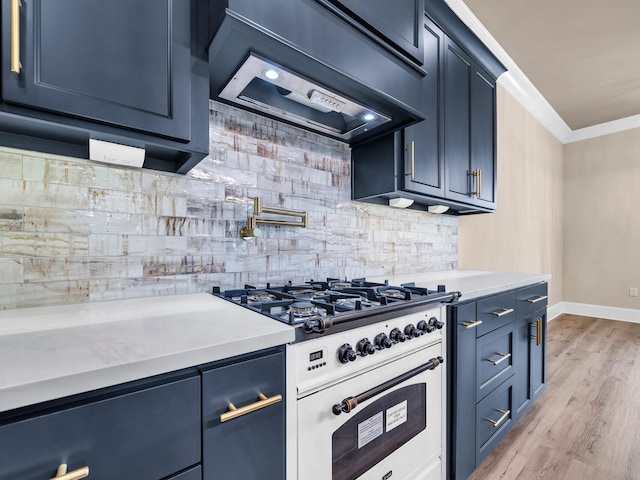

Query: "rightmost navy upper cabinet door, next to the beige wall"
left=471, top=64, right=496, bottom=208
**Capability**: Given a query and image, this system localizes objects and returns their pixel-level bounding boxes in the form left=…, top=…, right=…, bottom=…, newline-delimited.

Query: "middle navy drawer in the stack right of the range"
left=476, top=325, right=514, bottom=401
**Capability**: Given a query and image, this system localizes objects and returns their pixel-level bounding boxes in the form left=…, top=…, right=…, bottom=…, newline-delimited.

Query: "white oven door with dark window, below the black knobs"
left=298, top=344, right=444, bottom=480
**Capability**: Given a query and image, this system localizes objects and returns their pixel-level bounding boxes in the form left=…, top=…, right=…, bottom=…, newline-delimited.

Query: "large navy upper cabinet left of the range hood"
left=0, top=0, right=208, bottom=172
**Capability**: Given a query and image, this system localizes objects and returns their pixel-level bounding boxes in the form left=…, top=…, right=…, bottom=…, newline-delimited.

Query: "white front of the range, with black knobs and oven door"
left=288, top=305, right=446, bottom=480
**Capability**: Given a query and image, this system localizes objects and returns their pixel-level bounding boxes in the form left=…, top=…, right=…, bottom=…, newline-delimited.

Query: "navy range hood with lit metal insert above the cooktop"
left=208, top=0, right=426, bottom=145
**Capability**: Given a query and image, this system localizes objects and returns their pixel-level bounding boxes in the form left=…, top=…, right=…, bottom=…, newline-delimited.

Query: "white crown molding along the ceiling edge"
left=445, top=0, right=640, bottom=144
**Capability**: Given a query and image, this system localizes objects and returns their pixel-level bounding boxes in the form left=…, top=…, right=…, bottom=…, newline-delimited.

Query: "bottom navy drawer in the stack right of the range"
left=476, top=377, right=513, bottom=465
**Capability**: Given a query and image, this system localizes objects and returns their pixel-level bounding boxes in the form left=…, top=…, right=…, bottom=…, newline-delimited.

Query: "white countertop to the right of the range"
left=367, top=270, right=551, bottom=301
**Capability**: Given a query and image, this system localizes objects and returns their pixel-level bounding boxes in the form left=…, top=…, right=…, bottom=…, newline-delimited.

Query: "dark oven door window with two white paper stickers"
left=332, top=383, right=427, bottom=480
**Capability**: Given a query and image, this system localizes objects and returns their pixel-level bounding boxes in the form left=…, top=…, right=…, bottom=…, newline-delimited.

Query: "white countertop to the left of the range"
left=0, top=293, right=295, bottom=412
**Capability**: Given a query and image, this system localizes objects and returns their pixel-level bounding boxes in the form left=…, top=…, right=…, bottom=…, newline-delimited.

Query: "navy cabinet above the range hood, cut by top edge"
left=320, top=0, right=424, bottom=65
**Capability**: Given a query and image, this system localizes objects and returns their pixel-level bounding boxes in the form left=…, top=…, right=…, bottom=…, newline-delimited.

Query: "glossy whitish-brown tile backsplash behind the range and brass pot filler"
left=0, top=102, right=458, bottom=309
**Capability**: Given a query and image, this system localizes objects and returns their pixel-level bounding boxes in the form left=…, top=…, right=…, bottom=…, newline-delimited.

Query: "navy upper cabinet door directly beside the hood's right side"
left=402, top=18, right=444, bottom=197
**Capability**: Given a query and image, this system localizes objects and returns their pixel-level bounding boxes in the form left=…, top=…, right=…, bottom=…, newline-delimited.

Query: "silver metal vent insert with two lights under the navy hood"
left=220, top=53, right=391, bottom=140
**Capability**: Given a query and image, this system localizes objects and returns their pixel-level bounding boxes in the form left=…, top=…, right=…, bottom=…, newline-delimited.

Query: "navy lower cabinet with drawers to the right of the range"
left=447, top=282, right=547, bottom=480
